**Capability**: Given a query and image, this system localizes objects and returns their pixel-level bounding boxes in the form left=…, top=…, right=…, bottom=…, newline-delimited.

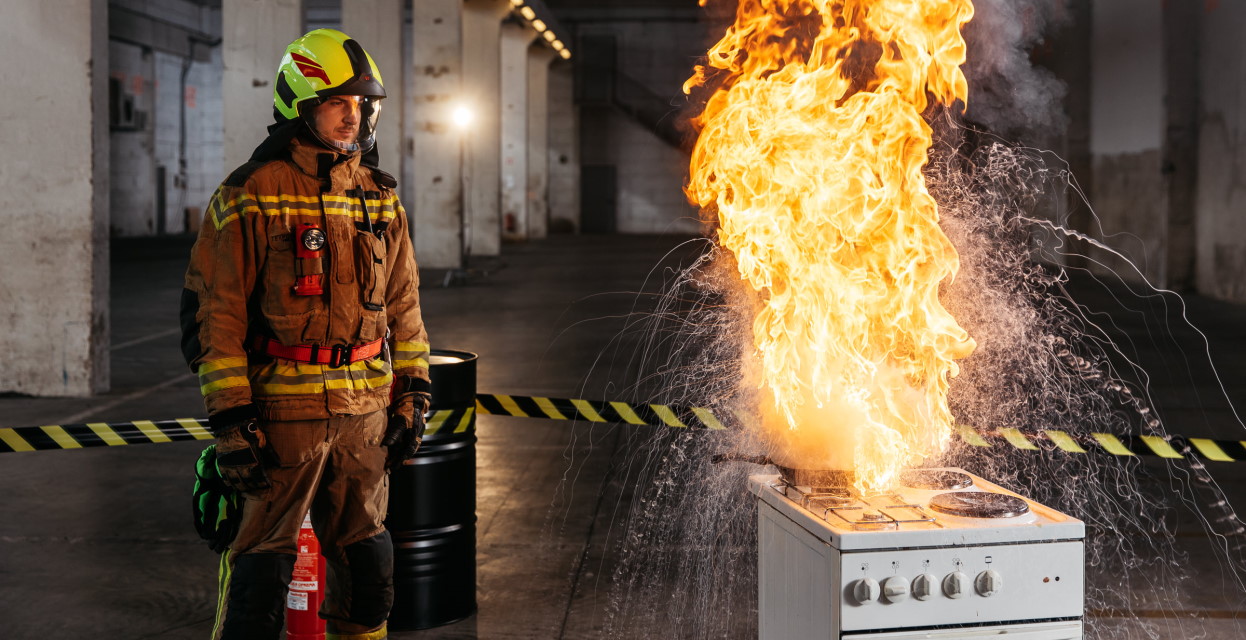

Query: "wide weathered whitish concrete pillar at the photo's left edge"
left=0, top=0, right=108, bottom=396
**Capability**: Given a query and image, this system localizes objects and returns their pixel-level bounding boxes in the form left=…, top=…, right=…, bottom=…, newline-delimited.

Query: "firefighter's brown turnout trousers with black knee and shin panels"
left=212, top=411, right=394, bottom=640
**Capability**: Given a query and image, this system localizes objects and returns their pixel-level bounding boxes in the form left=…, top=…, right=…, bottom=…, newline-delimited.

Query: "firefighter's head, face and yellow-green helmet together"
left=273, top=29, right=385, bottom=152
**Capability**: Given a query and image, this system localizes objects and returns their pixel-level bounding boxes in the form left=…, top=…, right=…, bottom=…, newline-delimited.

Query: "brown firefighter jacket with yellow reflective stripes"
left=182, top=139, right=429, bottom=420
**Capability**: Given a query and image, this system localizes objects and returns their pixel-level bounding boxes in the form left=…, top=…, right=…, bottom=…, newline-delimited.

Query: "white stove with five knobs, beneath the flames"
left=749, top=468, right=1085, bottom=640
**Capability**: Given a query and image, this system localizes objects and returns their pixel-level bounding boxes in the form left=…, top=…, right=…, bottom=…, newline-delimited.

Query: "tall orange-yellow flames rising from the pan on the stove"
left=684, top=0, right=974, bottom=492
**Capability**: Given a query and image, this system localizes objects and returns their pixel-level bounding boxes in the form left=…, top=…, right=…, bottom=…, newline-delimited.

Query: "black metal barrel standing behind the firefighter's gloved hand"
left=385, top=350, right=476, bottom=631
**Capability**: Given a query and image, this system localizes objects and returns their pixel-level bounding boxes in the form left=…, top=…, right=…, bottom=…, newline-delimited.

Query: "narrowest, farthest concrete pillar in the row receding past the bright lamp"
left=527, top=46, right=558, bottom=238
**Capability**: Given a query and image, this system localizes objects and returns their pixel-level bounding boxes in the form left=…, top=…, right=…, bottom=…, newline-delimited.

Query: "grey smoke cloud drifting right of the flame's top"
left=961, top=0, right=1069, bottom=142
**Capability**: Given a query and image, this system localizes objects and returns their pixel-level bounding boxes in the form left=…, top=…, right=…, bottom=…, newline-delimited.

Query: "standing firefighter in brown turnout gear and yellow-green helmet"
left=182, top=29, right=430, bottom=640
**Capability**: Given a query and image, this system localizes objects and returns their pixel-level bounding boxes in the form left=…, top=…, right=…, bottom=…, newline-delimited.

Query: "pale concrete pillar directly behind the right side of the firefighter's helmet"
left=341, top=0, right=403, bottom=188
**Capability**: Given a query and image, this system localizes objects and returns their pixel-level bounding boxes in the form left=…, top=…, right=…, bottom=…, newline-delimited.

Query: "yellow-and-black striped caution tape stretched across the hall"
left=0, top=393, right=1246, bottom=462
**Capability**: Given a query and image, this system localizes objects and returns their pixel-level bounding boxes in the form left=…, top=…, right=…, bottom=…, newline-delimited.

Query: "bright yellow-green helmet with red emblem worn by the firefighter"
left=273, top=29, right=385, bottom=151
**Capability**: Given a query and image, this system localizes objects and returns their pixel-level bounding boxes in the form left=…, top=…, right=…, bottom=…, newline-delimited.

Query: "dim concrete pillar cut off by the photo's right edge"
left=1194, top=2, right=1246, bottom=303
